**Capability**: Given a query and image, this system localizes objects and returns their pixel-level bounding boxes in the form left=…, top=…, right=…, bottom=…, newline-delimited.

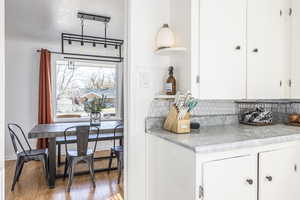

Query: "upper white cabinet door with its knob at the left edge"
left=247, top=0, right=290, bottom=99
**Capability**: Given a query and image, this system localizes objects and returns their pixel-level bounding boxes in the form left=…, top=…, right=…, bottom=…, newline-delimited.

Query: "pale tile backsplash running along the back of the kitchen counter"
left=146, top=100, right=300, bottom=130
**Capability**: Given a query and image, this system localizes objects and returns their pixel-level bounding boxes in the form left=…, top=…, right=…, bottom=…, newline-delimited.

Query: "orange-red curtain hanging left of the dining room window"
left=37, top=49, right=53, bottom=149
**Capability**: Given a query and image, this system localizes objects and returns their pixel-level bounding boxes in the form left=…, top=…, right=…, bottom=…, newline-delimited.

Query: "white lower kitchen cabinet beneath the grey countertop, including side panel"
left=147, top=135, right=300, bottom=200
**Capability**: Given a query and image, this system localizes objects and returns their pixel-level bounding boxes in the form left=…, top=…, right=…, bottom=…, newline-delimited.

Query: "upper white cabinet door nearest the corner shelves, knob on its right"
left=199, top=0, right=247, bottom=99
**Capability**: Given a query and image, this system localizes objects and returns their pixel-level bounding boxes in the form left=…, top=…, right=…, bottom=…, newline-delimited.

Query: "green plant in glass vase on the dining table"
left=84, top=95, right=106, bottom=126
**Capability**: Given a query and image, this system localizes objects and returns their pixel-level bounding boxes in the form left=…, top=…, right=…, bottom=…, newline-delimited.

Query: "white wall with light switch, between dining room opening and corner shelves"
left=125, top=0, right=170, bottom=200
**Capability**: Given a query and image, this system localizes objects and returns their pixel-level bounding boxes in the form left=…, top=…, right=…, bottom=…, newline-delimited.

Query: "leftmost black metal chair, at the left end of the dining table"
left=8, top=123, right=48, bottom=191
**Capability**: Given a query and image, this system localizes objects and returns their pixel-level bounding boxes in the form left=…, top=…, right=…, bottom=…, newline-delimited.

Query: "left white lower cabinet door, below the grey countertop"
left=203, top=156, right=257, bottom=200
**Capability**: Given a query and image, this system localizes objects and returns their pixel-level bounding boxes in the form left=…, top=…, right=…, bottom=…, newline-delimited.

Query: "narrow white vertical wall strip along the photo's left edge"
left=0, top=1, right=5, bottom=200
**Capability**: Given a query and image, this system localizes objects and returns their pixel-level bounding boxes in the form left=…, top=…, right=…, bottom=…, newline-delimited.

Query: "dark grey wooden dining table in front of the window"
left=28, top=121, right=123, bottom=188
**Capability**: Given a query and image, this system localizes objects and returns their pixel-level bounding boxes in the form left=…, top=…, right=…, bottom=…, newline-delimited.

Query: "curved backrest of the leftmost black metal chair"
left=7, top=123, right=32, bottom=155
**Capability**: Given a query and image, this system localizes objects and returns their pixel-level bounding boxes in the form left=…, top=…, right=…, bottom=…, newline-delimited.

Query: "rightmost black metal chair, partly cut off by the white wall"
left=108, top=123, right=124, bottom=184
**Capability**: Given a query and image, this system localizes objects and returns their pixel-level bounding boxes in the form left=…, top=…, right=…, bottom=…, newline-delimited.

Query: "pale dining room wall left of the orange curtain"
left=5, top=39, right=55, bottom=159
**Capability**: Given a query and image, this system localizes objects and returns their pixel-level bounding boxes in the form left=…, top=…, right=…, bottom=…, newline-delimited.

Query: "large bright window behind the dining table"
left=53, top=60, right=121, bottom=121
